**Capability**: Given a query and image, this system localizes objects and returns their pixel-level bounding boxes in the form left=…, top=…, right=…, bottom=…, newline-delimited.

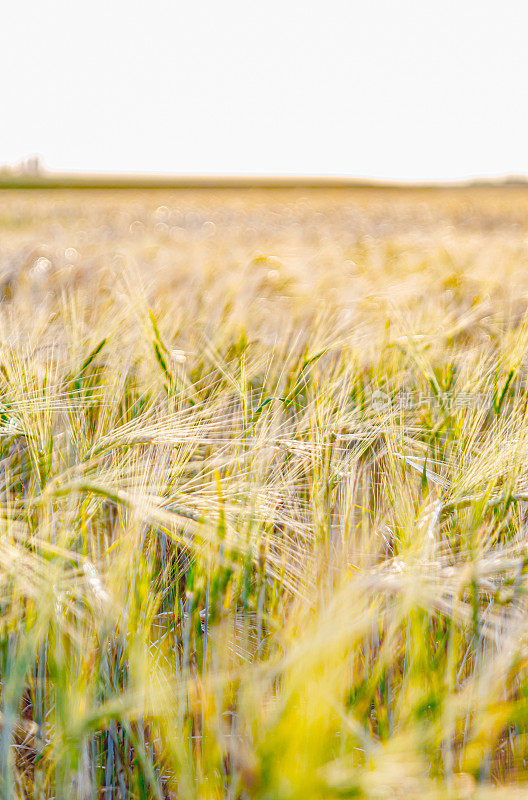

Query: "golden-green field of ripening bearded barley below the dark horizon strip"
left=0, top=186, right=528, bottom=800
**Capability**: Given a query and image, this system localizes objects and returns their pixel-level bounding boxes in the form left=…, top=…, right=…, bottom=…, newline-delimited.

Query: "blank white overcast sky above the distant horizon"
left=4, top=0, right=528, bottom=180
